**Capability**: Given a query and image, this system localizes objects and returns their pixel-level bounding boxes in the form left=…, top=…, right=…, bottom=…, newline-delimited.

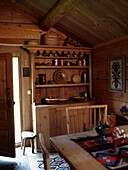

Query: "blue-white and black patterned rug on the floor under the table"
left=37, top=156, right=70, bottom=170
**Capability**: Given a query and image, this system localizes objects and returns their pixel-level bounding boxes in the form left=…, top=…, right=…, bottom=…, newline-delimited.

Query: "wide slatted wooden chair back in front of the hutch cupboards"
left=66, top=105, right=107, bottom=134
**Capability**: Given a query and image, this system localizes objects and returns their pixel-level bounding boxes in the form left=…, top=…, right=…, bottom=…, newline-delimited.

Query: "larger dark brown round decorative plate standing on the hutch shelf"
left=53, top=70, right=67, bottom=84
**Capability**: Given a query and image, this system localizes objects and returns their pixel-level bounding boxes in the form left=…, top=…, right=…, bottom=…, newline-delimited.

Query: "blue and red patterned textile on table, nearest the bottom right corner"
left=91, top=147, right=128, bottom=169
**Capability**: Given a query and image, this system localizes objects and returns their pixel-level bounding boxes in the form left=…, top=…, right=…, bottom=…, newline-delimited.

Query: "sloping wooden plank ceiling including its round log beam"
left=3, top=0, right=128, bottom=46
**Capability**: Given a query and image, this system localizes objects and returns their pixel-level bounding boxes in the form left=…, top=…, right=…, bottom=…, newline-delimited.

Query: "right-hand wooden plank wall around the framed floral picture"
left=92, top=39, right=128, bottom=113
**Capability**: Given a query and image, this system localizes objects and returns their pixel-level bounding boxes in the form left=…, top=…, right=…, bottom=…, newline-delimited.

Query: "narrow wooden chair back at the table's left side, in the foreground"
left=39, top=133, right=51, bottom=170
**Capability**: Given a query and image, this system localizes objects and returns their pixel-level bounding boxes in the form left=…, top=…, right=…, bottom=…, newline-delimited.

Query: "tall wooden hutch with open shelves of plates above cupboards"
left=27, top=45, right=95, bottom=151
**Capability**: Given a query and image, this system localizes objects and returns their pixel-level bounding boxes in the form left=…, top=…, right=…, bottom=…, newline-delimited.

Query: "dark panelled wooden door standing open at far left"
left=0, top=53, right=15, bottom=157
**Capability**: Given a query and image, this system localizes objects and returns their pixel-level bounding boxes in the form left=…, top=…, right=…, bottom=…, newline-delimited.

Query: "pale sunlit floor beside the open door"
left=0, top=147, right=58, bottom=170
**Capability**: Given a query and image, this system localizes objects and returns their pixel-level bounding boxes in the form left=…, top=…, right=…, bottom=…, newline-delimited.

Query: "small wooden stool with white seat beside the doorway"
left=21, top=131, right=36, bottom=155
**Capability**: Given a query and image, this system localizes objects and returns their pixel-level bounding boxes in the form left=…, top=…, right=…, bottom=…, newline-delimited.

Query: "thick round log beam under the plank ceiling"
left=40, top=0, right=80, bottom=31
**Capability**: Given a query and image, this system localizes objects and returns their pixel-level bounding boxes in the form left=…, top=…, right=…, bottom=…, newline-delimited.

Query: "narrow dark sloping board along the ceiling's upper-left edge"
left=3, top=0, right=39, bottom=23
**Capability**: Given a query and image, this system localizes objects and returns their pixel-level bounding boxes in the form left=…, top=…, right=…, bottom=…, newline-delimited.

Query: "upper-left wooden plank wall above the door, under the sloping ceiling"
left=0, top=3, right=42, bottom=44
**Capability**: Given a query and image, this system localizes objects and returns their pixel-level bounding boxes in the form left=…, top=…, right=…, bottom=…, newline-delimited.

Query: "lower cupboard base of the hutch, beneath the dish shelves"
left=33, top=101, right=95, bottom=151
